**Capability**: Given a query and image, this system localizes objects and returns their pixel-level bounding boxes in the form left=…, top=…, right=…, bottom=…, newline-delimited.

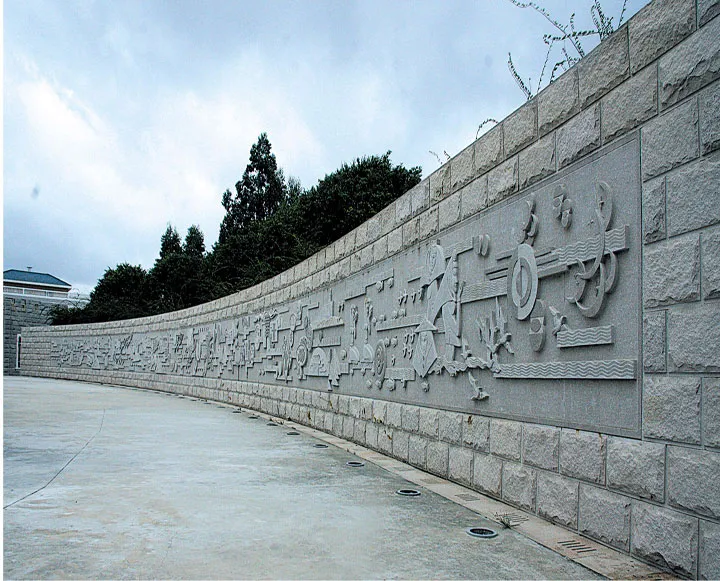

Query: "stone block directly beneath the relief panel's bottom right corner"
left=607, top=437, right=665, bottom=502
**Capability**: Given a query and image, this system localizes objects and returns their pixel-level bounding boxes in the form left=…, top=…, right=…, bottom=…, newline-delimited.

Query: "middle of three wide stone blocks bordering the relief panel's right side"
left=643, top=234, right=700, bottom=308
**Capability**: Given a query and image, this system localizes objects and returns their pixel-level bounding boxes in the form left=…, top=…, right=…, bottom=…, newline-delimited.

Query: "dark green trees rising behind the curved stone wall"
left=52, top=133, right=422, bottom=325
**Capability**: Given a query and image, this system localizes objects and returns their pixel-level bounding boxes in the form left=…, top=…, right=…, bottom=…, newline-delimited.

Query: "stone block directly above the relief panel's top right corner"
left=602, top=62, right=658, bottom=142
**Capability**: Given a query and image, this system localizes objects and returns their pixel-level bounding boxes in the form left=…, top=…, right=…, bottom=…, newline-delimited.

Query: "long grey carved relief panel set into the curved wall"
left=52, top=140, right=641, bottom=435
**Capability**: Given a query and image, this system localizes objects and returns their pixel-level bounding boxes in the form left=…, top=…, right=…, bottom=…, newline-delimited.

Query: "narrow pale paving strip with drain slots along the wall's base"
left=238, top=402, right=677, bottom=580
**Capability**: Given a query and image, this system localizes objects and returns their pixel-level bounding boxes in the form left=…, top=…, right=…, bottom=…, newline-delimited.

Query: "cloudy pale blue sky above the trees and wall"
left=3, top=0, right=646, bottom=292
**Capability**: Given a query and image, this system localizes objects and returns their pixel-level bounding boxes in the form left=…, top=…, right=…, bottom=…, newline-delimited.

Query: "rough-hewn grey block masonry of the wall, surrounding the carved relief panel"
left=16, top=0, right=720, bottom=579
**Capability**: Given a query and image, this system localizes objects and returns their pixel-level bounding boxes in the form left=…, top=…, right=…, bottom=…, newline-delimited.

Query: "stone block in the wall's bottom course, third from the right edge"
left=578, top=484, right=630, bottom=551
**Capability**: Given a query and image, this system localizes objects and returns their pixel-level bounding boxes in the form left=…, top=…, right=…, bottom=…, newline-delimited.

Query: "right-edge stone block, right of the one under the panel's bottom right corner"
left=668, top=446, right=720, bottom=518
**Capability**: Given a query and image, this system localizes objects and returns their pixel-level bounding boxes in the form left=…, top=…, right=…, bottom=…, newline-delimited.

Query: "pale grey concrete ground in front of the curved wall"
left=3, top=377, right=597, bottom=579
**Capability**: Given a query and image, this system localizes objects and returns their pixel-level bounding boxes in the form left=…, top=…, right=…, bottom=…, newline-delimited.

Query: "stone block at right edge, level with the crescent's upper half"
left=666, top=154, right=720, bottom=236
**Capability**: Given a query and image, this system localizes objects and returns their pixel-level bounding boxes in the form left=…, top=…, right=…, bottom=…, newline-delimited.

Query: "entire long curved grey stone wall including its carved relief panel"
left=16, top=0, right=720, bottom=578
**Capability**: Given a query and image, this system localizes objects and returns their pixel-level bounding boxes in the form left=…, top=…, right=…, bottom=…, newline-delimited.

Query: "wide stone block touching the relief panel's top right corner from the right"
left=642, top=98, right=700, bottom=180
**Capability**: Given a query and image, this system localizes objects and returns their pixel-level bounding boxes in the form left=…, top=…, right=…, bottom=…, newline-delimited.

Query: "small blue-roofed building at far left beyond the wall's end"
left=3, top=268, right=76, bottom=375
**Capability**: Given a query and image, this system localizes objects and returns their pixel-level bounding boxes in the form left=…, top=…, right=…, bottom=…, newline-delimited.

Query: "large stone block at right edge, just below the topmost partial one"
left=658, top=15, right=720, bottom=109
